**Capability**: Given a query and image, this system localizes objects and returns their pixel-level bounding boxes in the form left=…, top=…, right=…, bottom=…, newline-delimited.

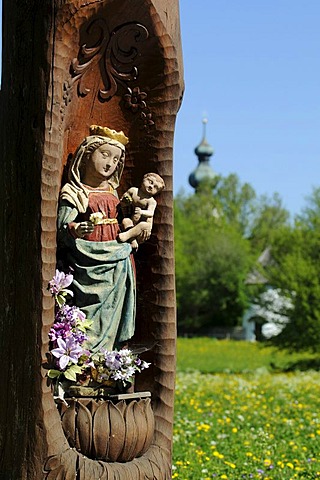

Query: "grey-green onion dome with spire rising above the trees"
left=189, top=118, right=217, bottom=190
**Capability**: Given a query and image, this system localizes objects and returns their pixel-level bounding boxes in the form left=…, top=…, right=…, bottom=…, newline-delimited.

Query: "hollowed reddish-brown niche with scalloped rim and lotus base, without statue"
left=41, top=0, right=182, bottom=480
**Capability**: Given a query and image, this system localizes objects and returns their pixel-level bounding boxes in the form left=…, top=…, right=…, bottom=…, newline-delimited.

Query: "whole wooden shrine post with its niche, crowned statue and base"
left=0, top=0, right=183, bottom=480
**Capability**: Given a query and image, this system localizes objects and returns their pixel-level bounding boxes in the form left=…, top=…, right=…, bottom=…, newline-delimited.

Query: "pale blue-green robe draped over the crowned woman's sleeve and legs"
left=58, top=201, right=136, bottom=353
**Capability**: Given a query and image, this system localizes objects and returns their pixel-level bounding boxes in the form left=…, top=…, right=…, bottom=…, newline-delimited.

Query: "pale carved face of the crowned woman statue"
left=85, top=143, right=121, bottom=184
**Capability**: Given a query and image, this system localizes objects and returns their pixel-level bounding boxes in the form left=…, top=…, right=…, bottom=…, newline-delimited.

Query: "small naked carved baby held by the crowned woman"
left=117, top=173, right=165, bottom=248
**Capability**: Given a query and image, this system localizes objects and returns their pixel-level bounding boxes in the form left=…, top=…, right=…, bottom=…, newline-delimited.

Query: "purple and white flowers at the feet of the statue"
left=48, top=270, right=150, bottom=398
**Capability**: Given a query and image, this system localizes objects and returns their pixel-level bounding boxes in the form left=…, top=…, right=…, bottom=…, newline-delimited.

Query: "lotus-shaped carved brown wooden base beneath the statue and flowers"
left=60, top=398, right=154, bottom=462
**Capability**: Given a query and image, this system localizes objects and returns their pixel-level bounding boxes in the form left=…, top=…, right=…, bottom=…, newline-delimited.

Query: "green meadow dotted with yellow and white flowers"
left=172, top=338, right=320, bottom=480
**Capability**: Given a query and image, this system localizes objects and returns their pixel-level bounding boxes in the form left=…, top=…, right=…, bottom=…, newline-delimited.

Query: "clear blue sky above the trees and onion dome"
left=174, top=0, right=320, bottom=214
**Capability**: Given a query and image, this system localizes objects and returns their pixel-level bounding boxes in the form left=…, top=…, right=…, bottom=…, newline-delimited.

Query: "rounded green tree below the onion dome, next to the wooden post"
left=175, top=182, right=252, bottom=330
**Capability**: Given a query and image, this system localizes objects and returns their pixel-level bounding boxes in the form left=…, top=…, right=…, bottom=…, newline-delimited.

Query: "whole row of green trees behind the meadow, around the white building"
left=175, top=174, right=320, bottom=351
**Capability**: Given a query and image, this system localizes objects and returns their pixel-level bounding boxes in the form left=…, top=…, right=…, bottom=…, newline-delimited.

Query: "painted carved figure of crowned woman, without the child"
left=58, top=126, right=135, bottom=353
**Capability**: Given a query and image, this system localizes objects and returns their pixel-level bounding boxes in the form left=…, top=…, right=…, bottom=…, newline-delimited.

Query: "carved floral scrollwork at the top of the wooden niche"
left=61, top=18, right=154, bottom=129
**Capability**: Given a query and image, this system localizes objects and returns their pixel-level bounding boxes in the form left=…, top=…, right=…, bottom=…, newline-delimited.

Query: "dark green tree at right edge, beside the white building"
left=269, top=222, right=320, bottom=351
